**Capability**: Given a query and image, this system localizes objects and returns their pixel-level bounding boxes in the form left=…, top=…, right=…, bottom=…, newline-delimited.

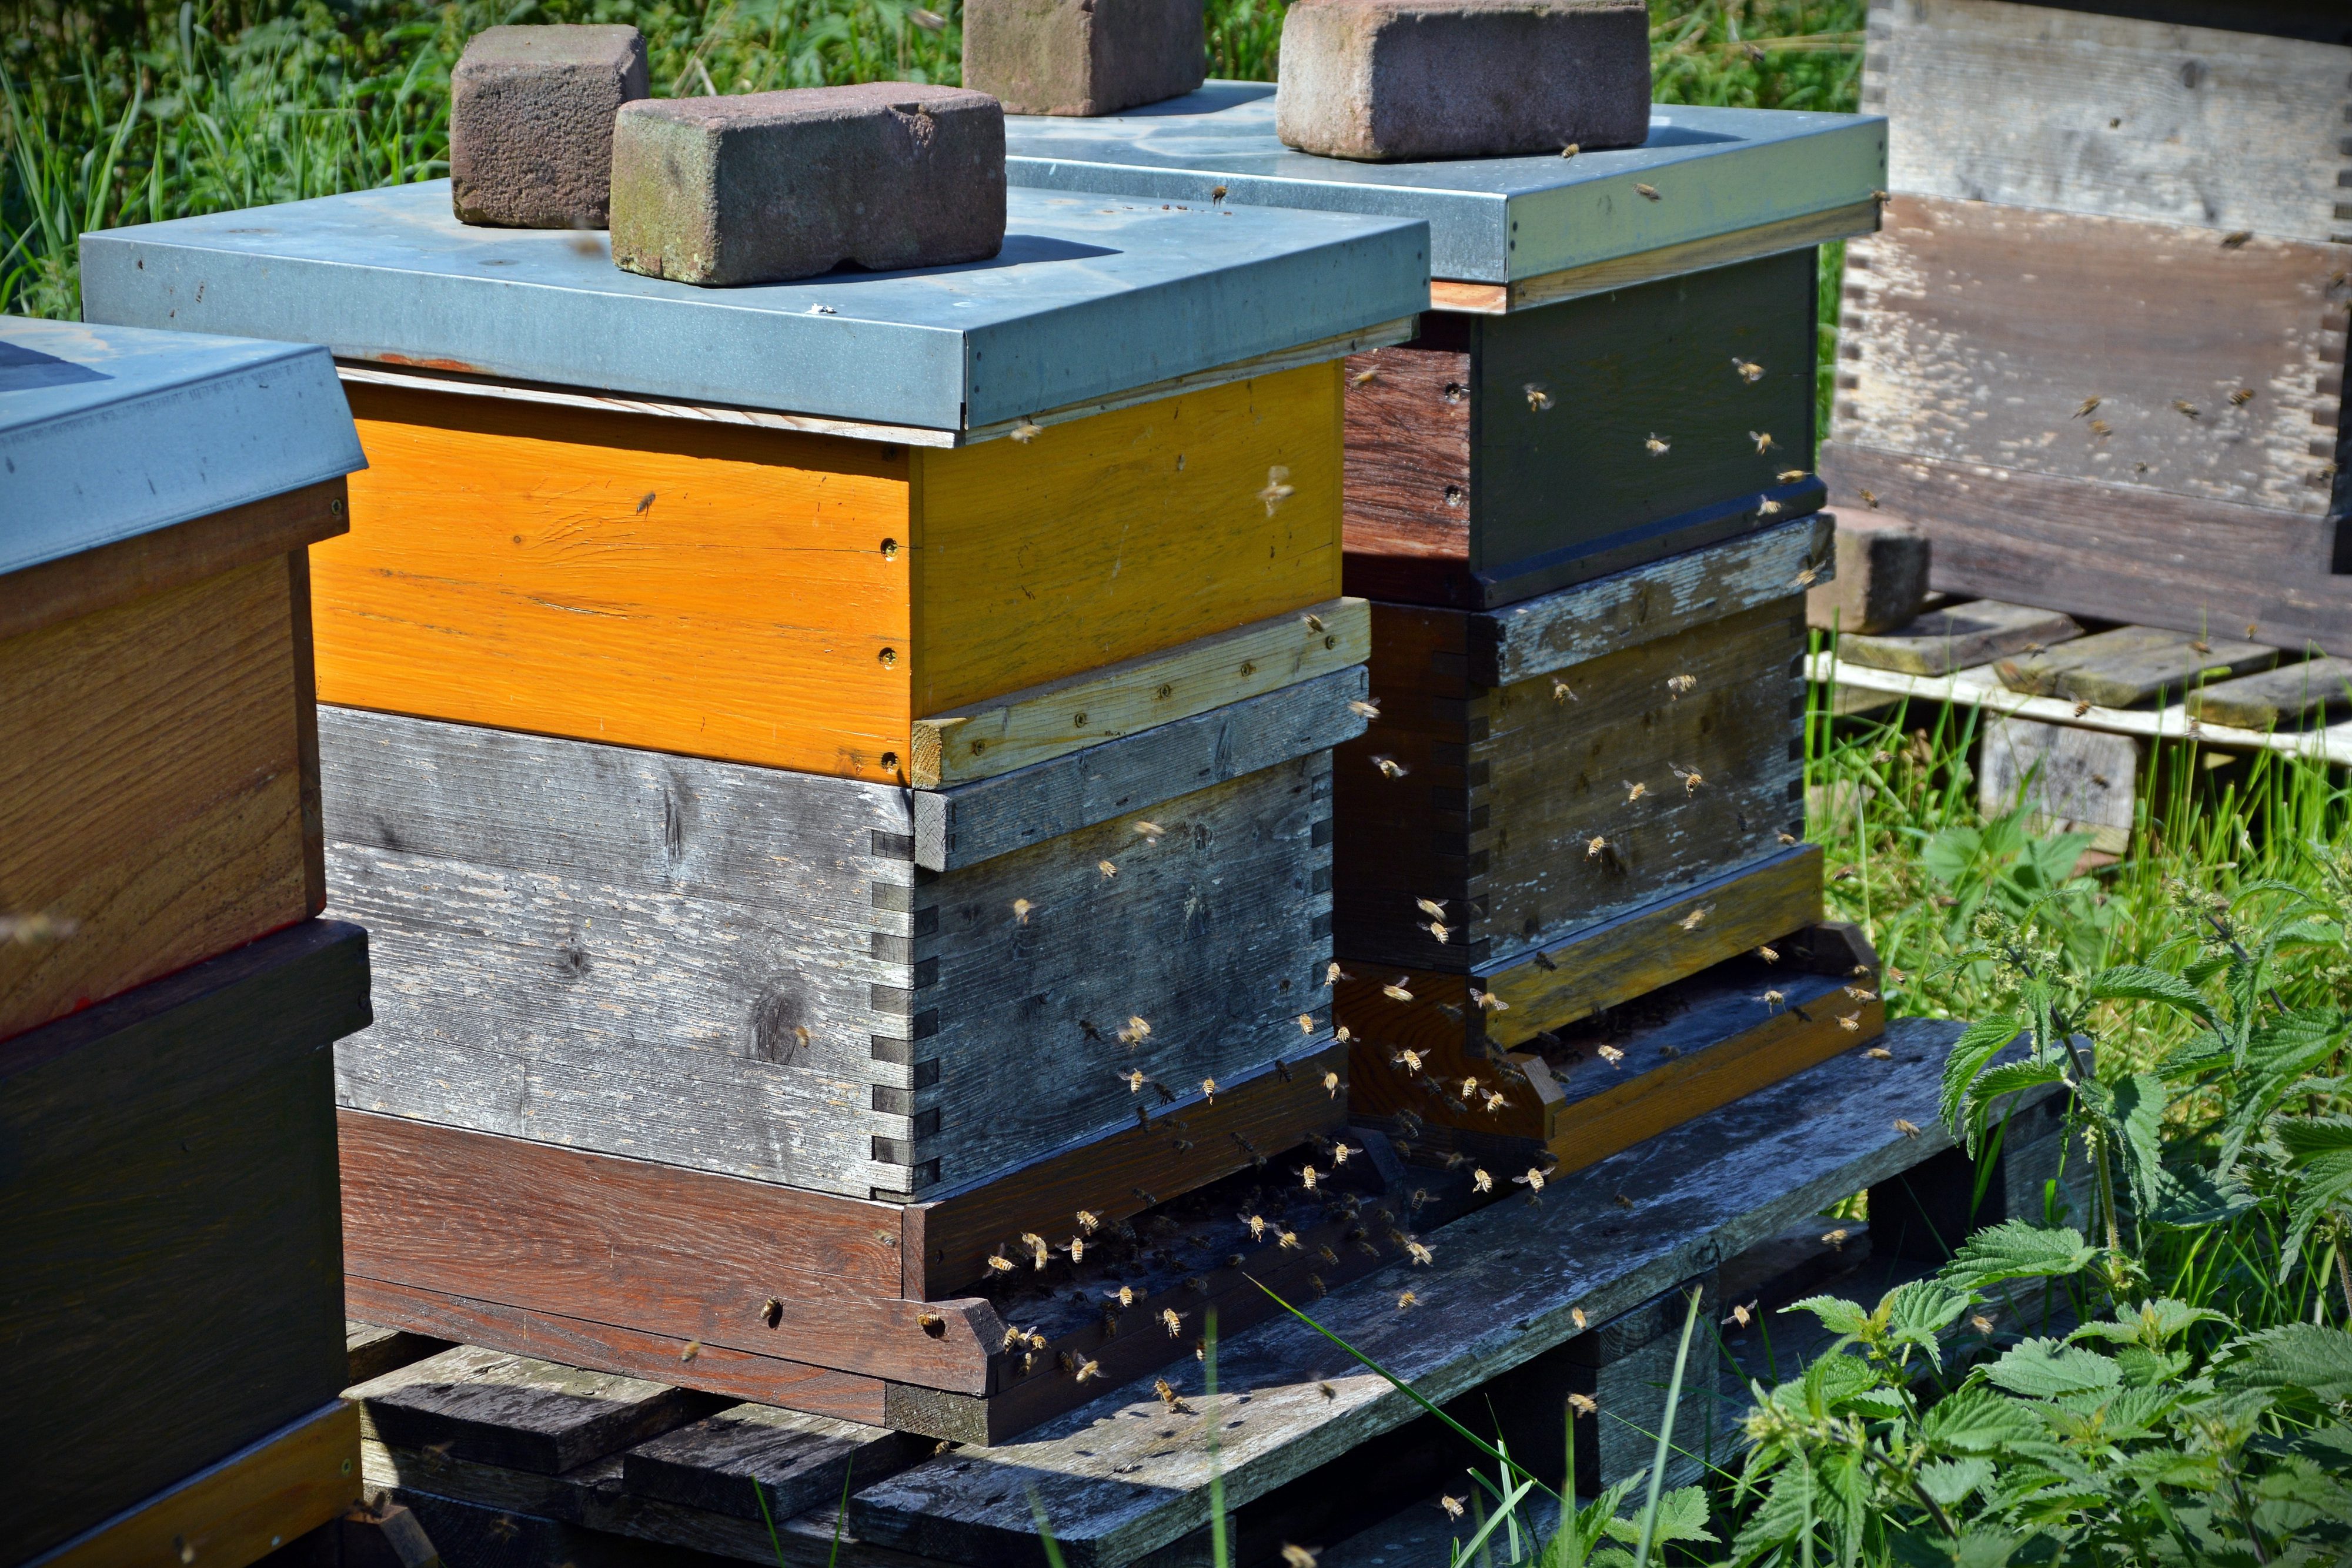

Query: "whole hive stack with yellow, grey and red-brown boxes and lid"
left=87, top=186, right=1428, bottom=1439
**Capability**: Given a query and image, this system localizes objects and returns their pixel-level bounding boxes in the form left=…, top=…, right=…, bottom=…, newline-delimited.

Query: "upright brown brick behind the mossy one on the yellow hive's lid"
left=449, top=26, right=649, bottom=228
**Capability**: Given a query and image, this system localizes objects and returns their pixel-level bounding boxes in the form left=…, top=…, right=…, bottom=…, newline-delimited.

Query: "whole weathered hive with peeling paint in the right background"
left=1823, top=0, right=2352, bottom=654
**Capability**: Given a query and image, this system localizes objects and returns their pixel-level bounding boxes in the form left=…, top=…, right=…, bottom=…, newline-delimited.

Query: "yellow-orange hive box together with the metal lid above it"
left=87, top=186, right=1425, bottom=785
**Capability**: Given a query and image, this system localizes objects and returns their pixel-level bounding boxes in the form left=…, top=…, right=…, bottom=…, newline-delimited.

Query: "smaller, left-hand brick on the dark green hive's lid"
left=964, top=0, right=1209, bottom=115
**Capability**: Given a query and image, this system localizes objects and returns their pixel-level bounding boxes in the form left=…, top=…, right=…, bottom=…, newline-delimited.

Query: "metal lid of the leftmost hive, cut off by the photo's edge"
left=0, top=315, right=367, bottom=574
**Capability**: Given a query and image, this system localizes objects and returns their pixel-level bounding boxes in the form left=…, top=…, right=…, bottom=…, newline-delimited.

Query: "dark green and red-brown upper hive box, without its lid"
left=1345, top=247, right=1823, bottom=609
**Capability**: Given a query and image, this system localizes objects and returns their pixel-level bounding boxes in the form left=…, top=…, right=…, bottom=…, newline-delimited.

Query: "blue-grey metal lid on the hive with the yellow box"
left=82, top=181, right=1428, bottom=430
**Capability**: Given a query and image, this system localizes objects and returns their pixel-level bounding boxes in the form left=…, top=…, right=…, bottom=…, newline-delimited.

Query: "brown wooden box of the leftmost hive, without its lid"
left=0, top=555, right=315, bottom=1037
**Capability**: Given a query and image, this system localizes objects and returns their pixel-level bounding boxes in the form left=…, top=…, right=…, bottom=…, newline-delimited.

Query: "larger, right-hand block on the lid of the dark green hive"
left=1275, top=0, right=1649, bottom=160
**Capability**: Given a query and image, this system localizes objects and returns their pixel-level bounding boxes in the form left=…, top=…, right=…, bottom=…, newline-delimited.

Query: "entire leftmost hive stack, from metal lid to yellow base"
left=0, top=317, right=367, bottom=1563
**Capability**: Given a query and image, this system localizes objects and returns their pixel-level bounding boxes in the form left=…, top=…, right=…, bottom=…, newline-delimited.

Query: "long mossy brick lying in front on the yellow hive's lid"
left=612, top=82, right=1004, bottom=285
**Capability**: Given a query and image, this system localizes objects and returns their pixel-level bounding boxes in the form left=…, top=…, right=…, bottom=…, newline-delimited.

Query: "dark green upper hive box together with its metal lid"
left=1007, top=82, right=1886, bottom=609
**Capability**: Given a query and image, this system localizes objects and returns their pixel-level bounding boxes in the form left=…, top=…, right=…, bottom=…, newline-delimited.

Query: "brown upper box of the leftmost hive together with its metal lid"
left=0, top=317, right=362, bottom=1039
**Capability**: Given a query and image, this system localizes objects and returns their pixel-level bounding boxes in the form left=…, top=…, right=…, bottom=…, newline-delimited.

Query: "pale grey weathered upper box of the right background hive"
left=1863, top=0, right=2352, bottom=242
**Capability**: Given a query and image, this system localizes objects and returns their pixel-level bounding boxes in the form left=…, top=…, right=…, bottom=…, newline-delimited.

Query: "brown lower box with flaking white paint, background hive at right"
left=1832, top=195, right=2345, bottom=521
